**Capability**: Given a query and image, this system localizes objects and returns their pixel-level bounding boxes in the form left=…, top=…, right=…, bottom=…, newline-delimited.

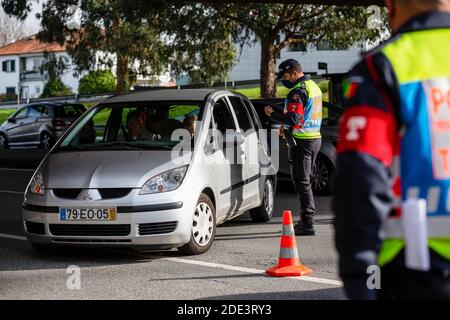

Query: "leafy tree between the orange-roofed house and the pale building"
left=33, top=0, right=166, bottom=94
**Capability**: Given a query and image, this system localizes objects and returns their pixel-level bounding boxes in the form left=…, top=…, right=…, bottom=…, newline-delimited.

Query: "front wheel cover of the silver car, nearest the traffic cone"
left=192, top=202, right=214, bottom=247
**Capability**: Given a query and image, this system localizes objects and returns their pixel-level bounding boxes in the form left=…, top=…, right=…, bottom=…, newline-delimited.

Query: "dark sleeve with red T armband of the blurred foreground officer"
left=333, top=52, right=398, bottom=299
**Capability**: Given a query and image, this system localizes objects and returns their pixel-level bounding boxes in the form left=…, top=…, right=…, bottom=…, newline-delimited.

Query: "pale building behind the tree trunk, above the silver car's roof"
left=229, top=42, right=366, bottom=81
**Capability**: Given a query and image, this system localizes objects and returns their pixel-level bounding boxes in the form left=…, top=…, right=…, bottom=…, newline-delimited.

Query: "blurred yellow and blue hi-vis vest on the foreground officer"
left=378, top=28, right=450, bottom=266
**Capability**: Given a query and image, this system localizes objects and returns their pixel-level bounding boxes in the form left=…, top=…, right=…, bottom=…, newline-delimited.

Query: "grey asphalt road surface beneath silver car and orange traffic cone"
left=0, top=169, right=344, bottom=300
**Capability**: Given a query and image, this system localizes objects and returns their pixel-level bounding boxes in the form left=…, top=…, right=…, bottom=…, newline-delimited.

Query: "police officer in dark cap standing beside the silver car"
left=265, top=59, right=322, bottom=236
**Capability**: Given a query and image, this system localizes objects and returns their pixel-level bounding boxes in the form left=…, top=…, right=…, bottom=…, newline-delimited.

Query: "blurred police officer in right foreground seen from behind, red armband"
left=333, top=0, right=450, bottom=299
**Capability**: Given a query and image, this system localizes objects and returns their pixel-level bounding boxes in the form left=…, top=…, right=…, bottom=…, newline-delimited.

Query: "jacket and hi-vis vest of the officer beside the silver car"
left=272, top=75, right=322, bottom=139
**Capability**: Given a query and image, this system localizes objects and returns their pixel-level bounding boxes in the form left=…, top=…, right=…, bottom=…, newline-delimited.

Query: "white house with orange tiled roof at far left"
left=0, top=36, right=79, bottom=99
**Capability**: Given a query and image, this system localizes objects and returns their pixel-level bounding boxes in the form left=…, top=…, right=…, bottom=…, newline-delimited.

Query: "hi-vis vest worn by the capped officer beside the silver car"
left=286, top=80, right=322, bottom=139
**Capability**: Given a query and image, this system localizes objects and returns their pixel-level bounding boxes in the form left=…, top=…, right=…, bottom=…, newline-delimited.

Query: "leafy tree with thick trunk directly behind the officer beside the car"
left=212, top=3, right=385, bottom=97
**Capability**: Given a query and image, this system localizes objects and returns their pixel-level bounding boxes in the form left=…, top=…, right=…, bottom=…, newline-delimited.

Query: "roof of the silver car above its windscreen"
left=102, top=89, right=216, bottom=104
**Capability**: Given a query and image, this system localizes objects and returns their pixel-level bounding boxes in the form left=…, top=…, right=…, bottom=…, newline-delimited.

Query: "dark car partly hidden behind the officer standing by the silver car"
left=252, top=99, right=343, bottom=194
